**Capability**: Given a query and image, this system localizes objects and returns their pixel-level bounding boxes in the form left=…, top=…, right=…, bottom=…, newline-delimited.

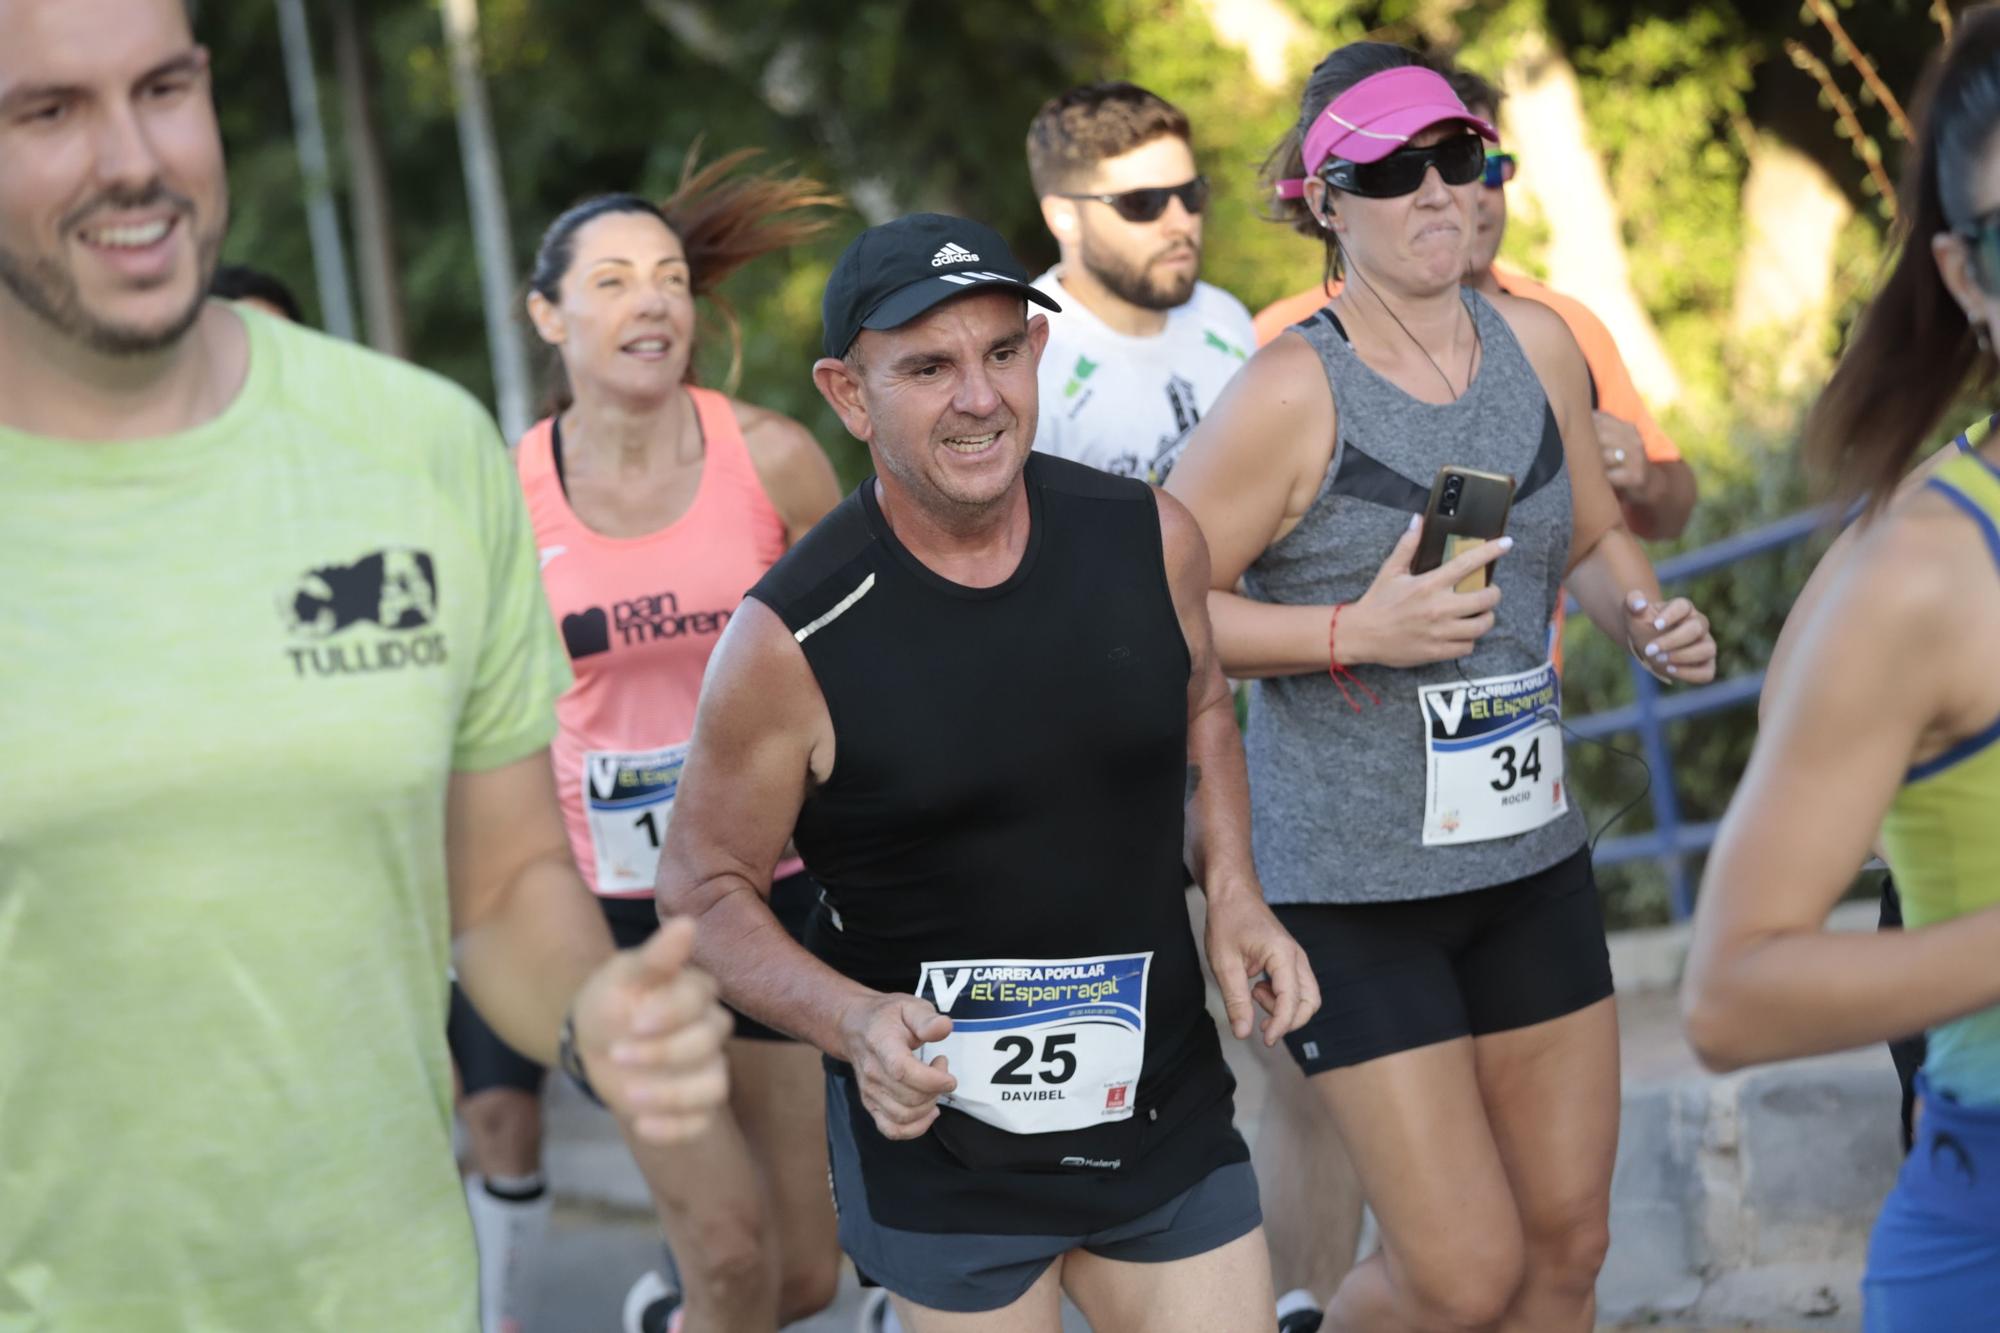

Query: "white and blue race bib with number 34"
left=1418, top=662, right=1570, bottom=847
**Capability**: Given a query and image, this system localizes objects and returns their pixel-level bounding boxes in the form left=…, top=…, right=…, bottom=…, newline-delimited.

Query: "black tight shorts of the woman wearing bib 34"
left=1272, top=849, right=1612, bottom=1075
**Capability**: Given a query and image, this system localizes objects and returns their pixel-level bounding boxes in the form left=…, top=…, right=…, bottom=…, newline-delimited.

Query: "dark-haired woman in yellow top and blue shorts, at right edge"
left=1684, top=8, right=2000, bottom=1333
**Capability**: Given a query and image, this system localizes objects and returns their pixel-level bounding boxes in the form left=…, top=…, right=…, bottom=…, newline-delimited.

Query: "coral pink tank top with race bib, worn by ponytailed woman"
left=514, top=386, right=798, bottom=899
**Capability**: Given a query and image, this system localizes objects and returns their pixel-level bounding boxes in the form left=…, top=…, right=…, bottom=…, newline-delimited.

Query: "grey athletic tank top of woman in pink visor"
left=1244, top=288, right=1586, bottom=903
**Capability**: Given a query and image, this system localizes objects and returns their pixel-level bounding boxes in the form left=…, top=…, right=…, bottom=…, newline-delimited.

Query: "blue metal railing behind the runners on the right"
left=1568, top=508, right=1834, bottom=921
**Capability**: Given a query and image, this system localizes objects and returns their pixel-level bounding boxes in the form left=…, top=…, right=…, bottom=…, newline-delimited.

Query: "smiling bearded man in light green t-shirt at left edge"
left=0, top=0, right=726, bottom=1333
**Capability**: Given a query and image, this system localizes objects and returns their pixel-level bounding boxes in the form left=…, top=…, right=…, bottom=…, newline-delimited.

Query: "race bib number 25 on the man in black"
left=916, top=953, right=1152, bottom=1135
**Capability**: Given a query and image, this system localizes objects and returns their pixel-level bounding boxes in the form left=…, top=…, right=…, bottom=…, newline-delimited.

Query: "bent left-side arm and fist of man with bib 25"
left=656, top=598, right=956, bottom=1139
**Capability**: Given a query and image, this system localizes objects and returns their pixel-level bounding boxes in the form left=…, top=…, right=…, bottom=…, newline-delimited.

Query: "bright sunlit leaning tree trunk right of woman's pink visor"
left=1500, top=34, right=1680, bottom=408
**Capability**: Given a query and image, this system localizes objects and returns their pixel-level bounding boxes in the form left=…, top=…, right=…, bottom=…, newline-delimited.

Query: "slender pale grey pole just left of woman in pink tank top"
left=440, top=0, right=528, bottom=440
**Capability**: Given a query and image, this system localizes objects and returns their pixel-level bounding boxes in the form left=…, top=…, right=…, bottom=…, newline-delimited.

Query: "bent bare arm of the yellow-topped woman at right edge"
left=1682, top=500, right=2000, bottom=1069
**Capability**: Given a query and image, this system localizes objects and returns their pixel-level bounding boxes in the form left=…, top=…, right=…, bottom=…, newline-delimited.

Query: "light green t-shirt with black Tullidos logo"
left=0, top=314, right=568, bottom=1333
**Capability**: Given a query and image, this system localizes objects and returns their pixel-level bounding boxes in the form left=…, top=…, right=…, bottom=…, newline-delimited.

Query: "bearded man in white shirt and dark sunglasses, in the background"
left=1028, top=82, right=1256, bottom=484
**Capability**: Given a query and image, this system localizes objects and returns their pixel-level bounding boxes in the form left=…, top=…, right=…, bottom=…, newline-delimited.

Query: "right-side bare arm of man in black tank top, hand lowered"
left=1154, top=490, right=1320, bottom=1045
